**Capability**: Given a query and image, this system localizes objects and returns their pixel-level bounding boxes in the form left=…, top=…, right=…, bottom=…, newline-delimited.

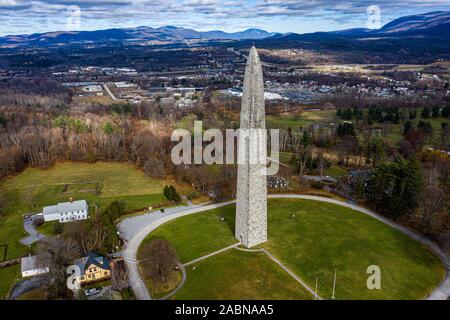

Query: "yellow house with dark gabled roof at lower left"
left=74, top=252, right=111, bottom=285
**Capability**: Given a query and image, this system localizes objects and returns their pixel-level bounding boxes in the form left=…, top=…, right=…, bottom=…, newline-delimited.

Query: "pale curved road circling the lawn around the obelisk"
left=120, top=194, right=450, bottom=300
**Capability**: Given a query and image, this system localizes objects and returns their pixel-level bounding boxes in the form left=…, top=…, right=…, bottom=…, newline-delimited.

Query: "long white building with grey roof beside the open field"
left=42, top=200, right=88, bottom=223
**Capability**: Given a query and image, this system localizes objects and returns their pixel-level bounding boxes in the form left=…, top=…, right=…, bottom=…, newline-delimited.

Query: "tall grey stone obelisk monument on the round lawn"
left=236, top=47, right=267, bottom=248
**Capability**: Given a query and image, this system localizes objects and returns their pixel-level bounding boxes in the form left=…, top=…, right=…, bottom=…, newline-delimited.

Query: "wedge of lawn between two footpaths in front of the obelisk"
left=173, top=249, right=312, bottom=300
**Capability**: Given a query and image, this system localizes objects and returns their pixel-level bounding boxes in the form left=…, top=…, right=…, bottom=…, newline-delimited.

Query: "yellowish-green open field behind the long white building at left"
left=0, top=162, right=191, bottom=260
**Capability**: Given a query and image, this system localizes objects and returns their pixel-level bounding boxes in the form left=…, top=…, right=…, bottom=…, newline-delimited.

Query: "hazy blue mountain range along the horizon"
left=0, top=11, right=450, bottom=47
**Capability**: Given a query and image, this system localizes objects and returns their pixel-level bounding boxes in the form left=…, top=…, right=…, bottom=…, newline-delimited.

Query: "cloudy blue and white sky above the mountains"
left=0, top=0, right=450, bottom=35
